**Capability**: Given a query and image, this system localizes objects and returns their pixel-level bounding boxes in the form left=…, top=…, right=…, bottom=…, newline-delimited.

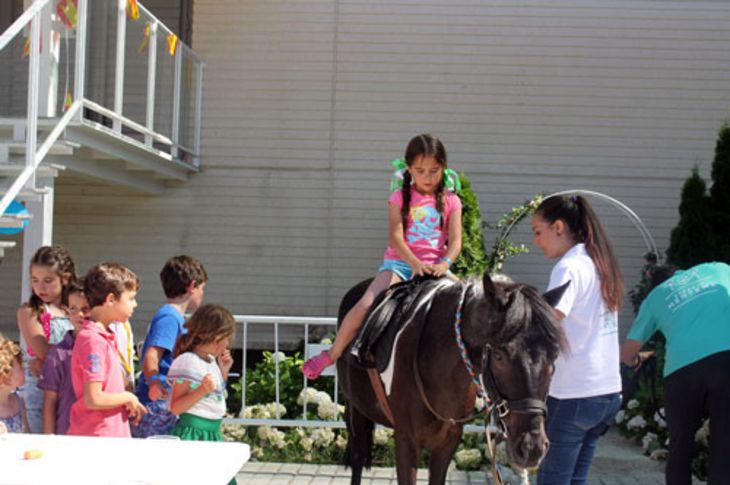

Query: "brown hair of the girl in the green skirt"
left=173, top=304, right=236, bottom=357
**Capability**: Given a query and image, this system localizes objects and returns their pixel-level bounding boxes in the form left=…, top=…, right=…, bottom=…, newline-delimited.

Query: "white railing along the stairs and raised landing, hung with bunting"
left=0, top=0, right=204, bottom=214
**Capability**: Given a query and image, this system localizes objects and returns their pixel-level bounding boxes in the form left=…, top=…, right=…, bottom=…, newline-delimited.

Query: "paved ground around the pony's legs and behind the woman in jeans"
left=236, top=430, right=664, bottom=485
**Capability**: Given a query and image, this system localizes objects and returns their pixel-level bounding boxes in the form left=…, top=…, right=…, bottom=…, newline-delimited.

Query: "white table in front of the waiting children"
left=0, top=433, right=250, bottom=485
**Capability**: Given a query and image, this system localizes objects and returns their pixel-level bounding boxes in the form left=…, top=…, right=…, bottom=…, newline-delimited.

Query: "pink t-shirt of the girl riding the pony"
left=383, top=188, right=461, bottom=264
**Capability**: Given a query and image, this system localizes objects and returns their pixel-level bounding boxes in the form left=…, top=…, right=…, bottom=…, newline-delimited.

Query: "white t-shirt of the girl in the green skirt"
left=167, top=352, right=226, bottom=419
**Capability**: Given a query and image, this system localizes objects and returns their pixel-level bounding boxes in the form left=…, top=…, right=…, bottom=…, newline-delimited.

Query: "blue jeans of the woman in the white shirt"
left=537, top=393, right=621, bottom=485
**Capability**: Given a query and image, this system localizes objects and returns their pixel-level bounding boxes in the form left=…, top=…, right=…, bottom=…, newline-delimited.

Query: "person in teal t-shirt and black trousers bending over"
left=621, top=263, right=730, bottom=485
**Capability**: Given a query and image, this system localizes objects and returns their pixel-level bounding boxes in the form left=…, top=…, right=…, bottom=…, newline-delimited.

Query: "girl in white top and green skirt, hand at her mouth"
left=167, top=305, right=236, bottom=483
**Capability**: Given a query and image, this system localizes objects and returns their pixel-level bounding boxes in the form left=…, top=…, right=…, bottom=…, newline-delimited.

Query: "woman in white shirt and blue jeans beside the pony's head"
left=532, top=196, right=624, bottom=485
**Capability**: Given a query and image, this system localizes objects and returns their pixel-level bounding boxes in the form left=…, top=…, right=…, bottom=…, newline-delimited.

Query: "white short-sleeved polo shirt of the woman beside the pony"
left=548, top=244, right=621, bottom=399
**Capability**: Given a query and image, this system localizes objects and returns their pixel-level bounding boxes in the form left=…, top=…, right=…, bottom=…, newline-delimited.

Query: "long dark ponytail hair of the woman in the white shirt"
left=535, top=195, right=625, bottom=311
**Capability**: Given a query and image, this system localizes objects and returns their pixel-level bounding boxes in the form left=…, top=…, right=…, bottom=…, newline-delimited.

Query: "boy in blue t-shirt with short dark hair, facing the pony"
left=132, top=255, right=208, bottom=438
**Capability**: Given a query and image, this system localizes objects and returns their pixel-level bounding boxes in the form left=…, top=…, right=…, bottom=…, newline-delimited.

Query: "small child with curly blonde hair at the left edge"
left=0, top=334, right=28, bottom=434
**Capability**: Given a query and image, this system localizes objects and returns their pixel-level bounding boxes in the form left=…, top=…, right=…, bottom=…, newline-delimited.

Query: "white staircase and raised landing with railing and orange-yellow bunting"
left=0, top=0, right=203, bottom=288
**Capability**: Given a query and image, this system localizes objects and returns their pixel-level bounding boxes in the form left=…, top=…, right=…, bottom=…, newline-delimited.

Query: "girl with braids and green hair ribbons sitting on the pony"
left=302, top=135, right=461, bottom=379
